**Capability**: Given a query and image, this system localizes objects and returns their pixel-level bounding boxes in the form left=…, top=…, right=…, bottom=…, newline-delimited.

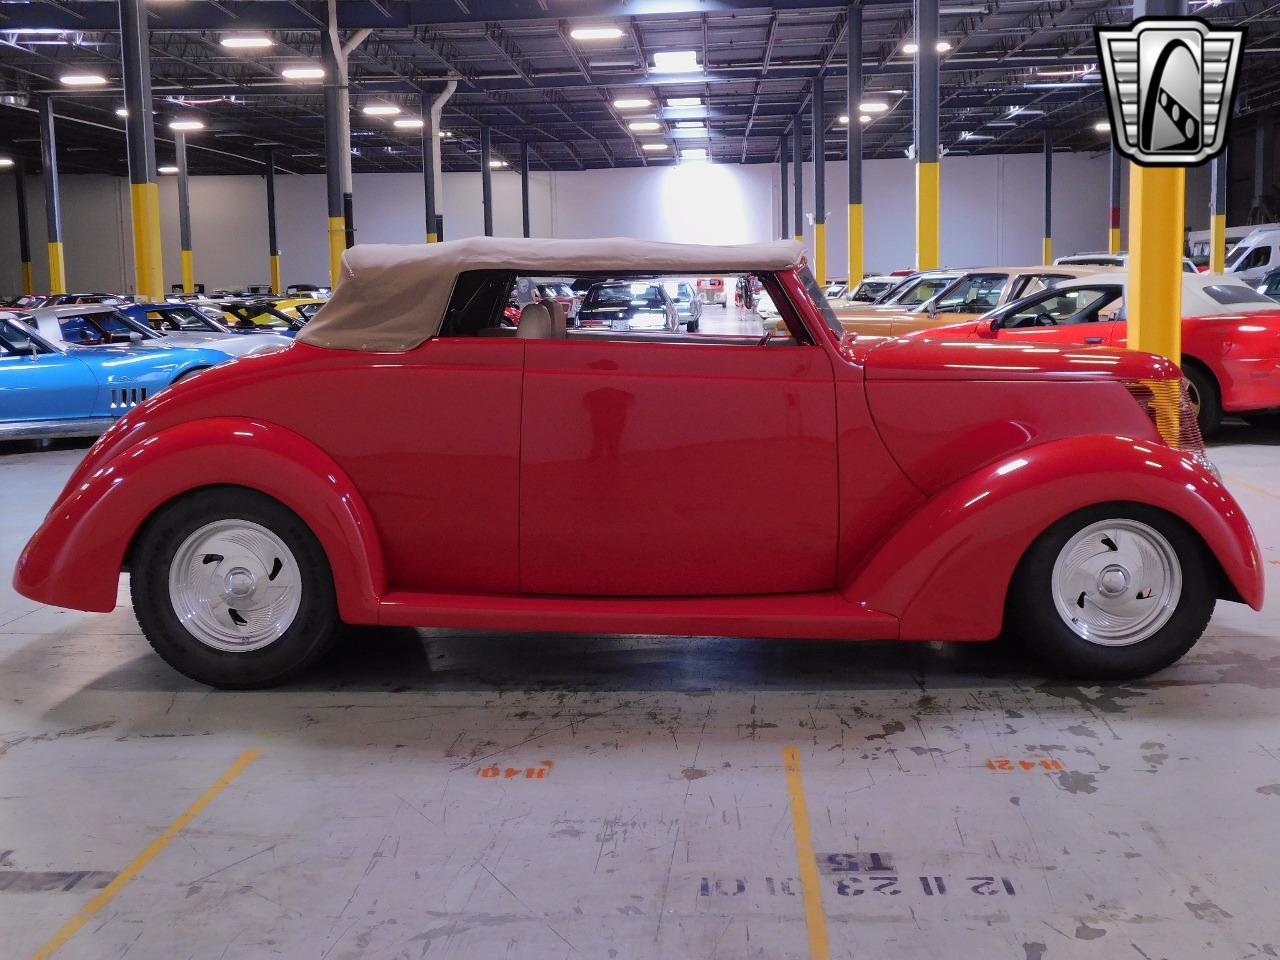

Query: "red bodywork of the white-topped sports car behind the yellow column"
left=913, top=310, right=1280, bottom=412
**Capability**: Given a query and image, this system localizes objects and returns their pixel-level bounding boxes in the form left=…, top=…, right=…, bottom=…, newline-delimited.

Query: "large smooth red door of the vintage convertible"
left=520, top=312, right=838, bottom=596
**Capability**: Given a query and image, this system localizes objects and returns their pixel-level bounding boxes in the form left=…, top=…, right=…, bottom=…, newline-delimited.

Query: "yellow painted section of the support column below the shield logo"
left=1128, top=164, right=1187, bottom=364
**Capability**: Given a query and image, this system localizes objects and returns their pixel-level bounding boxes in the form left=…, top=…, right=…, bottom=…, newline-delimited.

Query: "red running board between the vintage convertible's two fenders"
left=379, top=591, right=899, bottom=640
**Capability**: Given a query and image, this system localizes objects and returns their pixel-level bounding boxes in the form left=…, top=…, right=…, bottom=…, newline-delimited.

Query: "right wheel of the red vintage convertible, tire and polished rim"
left=1009, top=503, right=1216, bottom=680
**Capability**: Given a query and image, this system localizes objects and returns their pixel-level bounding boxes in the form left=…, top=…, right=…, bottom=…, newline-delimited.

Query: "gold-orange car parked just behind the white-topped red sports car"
left=836, top=266, right=1098, bottom=337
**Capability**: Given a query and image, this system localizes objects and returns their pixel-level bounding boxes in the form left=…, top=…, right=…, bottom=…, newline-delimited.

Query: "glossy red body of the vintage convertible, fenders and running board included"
left=14, top=271, right=1262, bottom=640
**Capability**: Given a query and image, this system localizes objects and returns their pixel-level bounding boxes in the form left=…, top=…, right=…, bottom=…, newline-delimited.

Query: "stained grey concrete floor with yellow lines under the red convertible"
left=0, top=424, right=1280, bottom=960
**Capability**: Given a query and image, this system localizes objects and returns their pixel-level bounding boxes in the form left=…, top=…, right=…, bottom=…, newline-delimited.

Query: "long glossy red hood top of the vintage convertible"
left=842, top=337, right=1178, bottom=380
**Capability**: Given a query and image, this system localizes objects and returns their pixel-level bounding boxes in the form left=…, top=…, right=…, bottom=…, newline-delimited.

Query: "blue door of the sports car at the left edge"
left=0, top=320, right=97, bottom=421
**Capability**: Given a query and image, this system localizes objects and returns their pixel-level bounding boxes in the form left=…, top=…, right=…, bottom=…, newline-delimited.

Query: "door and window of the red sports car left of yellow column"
left=997, top=283, right=1124, bottom=347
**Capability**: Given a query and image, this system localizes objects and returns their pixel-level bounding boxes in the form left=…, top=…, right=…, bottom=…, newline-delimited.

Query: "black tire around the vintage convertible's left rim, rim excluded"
left=129, top=486, right=339, bottom=690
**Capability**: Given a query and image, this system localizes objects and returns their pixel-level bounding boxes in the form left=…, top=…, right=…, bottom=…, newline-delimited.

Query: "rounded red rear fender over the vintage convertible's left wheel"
left=14, top=417, right=387, bottom=623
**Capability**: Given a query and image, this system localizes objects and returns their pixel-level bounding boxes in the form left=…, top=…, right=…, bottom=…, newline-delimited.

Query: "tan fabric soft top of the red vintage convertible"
left=298, top=237, right=804, bottom=353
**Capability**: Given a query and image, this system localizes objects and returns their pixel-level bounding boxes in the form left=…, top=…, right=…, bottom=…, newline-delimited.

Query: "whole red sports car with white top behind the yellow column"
left=911, top=270, right=1280, bottom=436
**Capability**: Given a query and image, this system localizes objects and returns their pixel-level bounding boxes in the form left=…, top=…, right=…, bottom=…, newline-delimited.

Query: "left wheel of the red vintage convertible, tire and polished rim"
left=131, top=488, right=338, bottom=689
